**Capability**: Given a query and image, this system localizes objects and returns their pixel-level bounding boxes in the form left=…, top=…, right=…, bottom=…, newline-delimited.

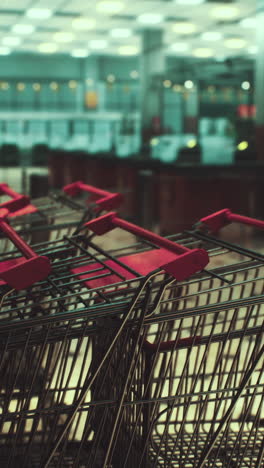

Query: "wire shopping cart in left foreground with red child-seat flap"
left=0, top=210, right=208, bottom=467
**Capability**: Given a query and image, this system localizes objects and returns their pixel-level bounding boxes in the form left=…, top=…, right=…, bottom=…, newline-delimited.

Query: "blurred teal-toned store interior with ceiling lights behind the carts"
left=0, top=0, right=264, bottom=234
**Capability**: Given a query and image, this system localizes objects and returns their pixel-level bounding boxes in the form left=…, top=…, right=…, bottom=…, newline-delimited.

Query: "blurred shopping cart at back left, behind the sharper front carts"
left=0, top=181, right=123, bottom=249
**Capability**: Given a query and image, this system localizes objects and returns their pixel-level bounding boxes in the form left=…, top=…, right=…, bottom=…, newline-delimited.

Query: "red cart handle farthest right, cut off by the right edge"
left=200, top=209, right=264, bottom=232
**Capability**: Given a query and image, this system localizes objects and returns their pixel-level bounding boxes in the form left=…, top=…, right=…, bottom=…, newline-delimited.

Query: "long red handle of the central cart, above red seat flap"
left=85, top=212, right=209, bottom=281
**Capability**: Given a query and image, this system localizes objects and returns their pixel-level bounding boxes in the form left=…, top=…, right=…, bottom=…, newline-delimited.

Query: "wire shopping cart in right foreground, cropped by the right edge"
left=69, top=210, right=264, bottom=468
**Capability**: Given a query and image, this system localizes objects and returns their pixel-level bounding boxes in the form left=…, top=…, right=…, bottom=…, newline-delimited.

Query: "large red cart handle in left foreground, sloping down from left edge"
left=0, top=209, right=51, bottom=290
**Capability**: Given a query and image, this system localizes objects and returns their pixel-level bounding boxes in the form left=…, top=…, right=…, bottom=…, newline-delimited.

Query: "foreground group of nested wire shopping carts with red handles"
left=0, top=183, right=264, bottom=468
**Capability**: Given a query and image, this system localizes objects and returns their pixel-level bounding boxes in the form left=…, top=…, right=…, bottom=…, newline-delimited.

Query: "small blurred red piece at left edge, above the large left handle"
left=0, top=184, right=37, bottom=217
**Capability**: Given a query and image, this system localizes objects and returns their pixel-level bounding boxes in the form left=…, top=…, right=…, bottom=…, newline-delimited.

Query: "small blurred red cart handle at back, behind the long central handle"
left=63, top=181, right=124, bottom=211
